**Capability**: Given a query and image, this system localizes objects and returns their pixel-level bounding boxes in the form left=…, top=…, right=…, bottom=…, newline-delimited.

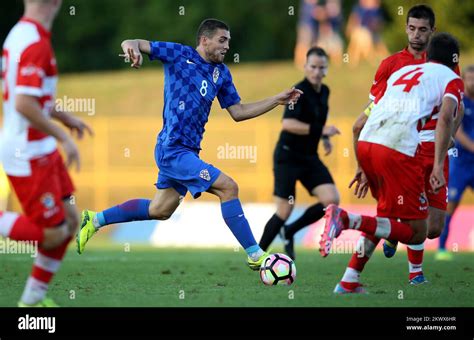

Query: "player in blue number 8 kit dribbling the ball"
left=76, top=19, right=302, bottom=270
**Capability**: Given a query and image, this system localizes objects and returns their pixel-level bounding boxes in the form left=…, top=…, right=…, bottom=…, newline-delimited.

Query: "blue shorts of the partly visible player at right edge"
left=448, top=156, right=474, bottom=202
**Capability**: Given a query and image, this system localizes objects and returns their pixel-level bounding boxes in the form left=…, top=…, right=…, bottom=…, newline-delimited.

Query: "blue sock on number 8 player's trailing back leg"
left=96, top=199, right=151, bottom=228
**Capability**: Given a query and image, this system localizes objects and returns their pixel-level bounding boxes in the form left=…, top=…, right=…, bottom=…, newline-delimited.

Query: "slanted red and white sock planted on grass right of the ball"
left=340, top=233, right=380, bottom=290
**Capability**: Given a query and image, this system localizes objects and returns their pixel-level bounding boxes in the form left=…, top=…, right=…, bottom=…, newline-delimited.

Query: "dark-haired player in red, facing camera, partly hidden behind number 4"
left=336, top=5, right=462, bottom=292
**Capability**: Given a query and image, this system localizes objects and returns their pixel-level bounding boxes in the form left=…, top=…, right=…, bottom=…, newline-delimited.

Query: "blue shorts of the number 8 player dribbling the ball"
left=155, top=144, right=221, bottom=198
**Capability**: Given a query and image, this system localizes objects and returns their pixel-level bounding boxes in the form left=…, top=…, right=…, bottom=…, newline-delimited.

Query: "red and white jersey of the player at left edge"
left=0, top=18, right=58, bottom=176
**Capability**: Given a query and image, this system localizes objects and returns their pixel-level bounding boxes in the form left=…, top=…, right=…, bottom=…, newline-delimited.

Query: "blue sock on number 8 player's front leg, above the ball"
left=221, top=198, right=260, bottom=255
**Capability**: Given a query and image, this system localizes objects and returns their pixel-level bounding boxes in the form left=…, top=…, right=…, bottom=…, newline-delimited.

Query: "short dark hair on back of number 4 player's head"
left=426, top=33, right=459, bottom=68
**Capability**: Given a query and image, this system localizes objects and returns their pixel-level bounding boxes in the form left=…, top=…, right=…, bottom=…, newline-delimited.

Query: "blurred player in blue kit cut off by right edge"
left=435, top=65, right=474, bottom=260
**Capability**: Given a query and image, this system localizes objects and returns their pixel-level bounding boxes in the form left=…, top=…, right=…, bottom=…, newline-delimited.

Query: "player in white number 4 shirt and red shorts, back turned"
left=321, top=33, right=463, bottom=293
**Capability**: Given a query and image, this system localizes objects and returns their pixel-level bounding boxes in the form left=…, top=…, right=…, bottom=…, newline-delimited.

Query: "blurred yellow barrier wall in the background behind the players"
left=25, top=113, right=474, bottom=209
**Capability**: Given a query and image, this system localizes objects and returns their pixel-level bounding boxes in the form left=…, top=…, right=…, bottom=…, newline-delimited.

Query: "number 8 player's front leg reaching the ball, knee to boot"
left=208, top=173, right=268, bottom=270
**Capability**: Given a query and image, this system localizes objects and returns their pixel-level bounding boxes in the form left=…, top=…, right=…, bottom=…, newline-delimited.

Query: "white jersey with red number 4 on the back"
left=359, top=62, right=464, bottom=156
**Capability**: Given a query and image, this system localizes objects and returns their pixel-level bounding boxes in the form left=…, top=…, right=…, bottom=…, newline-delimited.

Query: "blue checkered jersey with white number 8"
left=150, top=41, right=240, bottom=150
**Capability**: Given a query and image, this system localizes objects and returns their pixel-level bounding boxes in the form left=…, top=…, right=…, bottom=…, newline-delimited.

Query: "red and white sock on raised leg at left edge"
left=0, top=211, right=44, bottom=244
